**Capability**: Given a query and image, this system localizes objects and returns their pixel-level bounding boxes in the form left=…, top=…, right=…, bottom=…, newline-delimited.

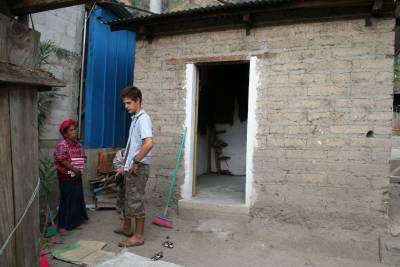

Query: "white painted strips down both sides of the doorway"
left=181, top=57, right=258, bottom=207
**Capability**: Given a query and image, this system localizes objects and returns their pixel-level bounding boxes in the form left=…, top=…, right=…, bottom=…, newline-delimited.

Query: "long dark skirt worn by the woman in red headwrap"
left=58, top=177, right=88, bottom=230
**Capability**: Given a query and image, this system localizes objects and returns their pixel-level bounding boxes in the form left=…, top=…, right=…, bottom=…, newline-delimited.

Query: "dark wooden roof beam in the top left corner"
left=9, top=0, right=91, bottom=16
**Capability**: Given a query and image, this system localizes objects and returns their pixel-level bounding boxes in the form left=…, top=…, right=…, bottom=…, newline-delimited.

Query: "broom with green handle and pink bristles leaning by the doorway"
left=152, top=127, right=187, bottom=228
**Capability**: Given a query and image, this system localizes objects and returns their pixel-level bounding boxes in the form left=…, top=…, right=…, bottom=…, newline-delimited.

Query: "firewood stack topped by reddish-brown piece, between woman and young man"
left=89, top=150, right=118, bottom=209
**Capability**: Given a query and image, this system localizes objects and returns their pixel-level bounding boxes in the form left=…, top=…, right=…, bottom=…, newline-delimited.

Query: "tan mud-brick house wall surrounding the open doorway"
left=135, top=19, right=395, bottom=227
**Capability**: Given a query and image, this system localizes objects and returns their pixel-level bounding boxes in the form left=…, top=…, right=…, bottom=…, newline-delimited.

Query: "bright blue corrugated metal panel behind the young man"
left=83, top=6, right=135, bottom=148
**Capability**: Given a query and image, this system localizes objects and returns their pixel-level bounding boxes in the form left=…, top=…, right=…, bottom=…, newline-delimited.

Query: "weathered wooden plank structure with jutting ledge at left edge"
left=0, top=14, right=65, bottom=267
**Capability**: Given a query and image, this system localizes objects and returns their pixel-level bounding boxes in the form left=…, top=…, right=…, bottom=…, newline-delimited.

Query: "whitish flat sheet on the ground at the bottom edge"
left=98, top=251, right=183, bottom=267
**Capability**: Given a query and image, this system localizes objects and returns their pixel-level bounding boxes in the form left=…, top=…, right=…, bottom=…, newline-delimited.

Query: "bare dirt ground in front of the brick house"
left=42, top=202, right=400, bottom=267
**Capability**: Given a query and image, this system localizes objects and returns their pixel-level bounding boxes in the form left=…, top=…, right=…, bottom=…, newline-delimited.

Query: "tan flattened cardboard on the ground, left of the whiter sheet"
left=53, top=240, right=115, bottom=266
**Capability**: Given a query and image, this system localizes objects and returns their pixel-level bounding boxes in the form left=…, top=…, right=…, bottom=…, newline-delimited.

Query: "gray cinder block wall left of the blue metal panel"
left=32, top=5, right=85, bottom=154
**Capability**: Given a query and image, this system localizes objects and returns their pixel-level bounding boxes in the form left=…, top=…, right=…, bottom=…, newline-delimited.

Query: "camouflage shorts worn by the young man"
left=124, top=165, right=150, bottom=218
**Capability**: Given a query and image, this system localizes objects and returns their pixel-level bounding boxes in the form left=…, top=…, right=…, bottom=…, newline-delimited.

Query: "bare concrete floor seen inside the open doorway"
left=193, top=174, right=246, bottom=205
